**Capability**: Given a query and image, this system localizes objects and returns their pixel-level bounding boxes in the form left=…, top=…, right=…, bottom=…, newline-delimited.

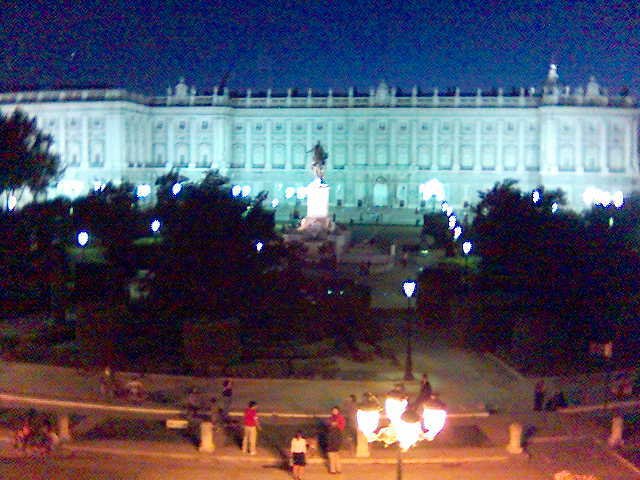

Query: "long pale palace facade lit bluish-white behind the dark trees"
left=0, top=65, right=640, bottom=222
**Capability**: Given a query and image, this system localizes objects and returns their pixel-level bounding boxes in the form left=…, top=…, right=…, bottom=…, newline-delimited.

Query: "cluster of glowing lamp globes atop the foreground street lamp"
left=356, top=392, right=447, bottom=452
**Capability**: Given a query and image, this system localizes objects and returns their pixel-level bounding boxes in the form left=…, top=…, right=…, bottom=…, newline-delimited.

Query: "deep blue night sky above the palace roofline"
left=0, top=0, right=640, bottom=94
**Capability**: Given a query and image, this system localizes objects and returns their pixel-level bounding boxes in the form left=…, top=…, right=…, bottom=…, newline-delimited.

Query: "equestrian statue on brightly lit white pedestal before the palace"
left=284, top=142, right=350, bottom=260
